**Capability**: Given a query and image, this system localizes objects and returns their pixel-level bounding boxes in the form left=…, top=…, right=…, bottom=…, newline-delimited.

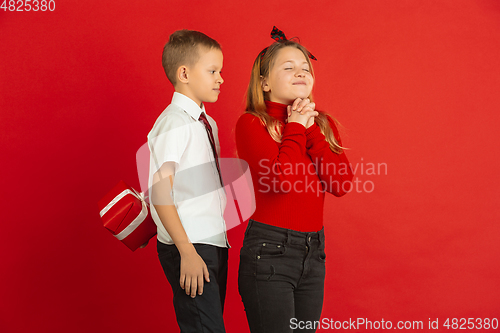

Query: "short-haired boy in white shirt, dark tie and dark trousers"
left=148, top=30, right=229, bottom=333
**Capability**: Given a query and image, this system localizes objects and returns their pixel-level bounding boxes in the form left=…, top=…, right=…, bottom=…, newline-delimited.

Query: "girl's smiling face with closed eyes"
left=262, top=46, right=314, bottom=105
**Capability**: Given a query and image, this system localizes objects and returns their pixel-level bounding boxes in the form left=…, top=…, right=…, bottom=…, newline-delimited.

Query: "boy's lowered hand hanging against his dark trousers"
left=179, top=245, right=210, bottom=298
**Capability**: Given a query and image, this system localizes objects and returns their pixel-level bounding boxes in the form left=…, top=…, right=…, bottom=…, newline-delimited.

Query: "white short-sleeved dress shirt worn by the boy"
left=148, top=92, right=229, bottom=247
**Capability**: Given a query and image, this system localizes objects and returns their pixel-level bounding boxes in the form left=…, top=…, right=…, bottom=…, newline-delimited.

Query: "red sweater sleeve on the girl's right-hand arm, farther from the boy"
left=306, top=117, right=353, bottom=197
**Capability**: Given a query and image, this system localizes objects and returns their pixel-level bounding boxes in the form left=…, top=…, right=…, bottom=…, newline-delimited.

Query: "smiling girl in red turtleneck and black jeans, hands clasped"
left=236, top=27, right=353, bottom=333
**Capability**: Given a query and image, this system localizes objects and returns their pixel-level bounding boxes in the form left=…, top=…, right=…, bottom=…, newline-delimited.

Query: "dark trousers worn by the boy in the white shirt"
left=157, top=241, right=228, bottom=333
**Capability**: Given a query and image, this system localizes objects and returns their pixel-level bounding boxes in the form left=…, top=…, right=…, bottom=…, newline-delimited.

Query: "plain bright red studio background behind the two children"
left=0, top=0, right=500, bottom=332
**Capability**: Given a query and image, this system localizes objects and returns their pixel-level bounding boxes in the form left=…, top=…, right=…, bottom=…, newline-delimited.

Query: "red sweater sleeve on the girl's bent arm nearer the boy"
left=235, top=114, right=306, bottom=191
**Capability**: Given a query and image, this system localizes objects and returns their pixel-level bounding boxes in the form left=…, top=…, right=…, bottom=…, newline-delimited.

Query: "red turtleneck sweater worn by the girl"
left=236, top=101, right=353, bottom=232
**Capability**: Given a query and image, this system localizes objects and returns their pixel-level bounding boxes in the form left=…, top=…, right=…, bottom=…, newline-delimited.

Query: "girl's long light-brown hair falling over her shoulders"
left=246, top=40, right=344, bottom=154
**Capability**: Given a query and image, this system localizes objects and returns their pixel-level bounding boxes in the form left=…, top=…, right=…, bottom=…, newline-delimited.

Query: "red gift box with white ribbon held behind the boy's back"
left=97, top=181, right=157, bottom=251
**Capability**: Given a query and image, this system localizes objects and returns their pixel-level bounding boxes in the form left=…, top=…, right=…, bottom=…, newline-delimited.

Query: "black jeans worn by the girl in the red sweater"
left=238, top=220, right=326, bottom=333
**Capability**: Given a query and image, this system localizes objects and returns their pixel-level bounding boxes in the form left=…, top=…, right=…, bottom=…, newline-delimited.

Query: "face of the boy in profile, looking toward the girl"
left=185, top=47, right=224, bottom=107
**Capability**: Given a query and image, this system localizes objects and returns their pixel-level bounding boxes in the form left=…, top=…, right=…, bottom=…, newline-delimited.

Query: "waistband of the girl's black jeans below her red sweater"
left=245, top=219, right=325, bottom=244
